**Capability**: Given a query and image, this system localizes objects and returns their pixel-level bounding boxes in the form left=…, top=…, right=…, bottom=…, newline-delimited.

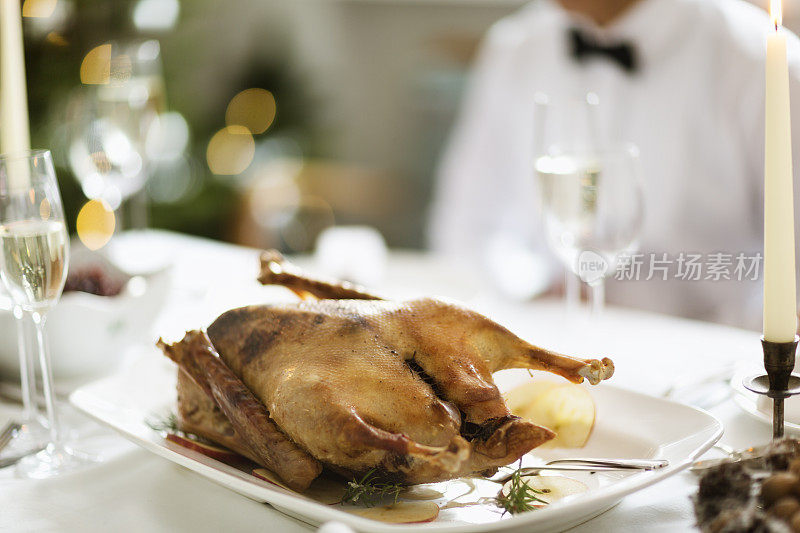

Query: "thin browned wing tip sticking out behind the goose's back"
left=258, top=250, right=382, bottom=300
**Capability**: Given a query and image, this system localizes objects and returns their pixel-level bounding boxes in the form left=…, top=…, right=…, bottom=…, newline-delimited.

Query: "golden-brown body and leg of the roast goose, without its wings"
left=208, top=299, right=613, bottom=483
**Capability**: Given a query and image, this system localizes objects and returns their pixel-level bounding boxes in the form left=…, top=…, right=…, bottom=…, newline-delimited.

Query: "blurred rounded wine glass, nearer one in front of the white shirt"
left=536, top=144, right=644, bottom=313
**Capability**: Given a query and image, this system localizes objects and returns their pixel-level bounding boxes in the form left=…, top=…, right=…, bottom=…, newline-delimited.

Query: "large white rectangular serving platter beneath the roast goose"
left=70, top=354, right=722, bottom=533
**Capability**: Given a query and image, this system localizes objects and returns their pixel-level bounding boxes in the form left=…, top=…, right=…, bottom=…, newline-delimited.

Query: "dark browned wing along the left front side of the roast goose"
left=158, top=331, right=322, bottom=490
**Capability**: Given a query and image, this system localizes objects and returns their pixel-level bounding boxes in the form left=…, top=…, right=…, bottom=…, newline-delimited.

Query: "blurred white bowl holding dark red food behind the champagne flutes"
left=0, top=243, right=171, bottom=380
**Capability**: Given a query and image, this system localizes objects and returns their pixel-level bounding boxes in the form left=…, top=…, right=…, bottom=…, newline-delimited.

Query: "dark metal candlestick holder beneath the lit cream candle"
left=743, top=335, right=800, bottom=439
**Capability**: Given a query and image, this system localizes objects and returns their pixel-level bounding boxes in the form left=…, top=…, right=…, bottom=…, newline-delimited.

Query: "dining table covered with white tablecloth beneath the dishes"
left=0, top=230, right=771, bottom=533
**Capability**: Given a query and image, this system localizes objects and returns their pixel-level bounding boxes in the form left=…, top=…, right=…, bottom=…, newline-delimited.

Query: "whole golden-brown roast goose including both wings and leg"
left=159, top=251, right=614, bottom=490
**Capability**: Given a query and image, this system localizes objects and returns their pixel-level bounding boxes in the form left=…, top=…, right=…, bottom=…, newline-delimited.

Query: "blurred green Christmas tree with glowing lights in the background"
left=23, top=0, right=312, bottom=238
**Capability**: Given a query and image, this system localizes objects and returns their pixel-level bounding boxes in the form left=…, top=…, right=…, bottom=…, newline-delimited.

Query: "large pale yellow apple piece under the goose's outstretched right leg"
left=504, top=381, right=596, bottom=448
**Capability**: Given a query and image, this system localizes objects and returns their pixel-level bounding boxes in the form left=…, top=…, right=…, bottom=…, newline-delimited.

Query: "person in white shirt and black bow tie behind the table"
left=430, top=0, right=800, bottom=328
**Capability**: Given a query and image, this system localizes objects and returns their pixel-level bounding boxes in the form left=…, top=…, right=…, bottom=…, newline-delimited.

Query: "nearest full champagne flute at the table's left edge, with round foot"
left=0, top=150, right=93, bottom=478
